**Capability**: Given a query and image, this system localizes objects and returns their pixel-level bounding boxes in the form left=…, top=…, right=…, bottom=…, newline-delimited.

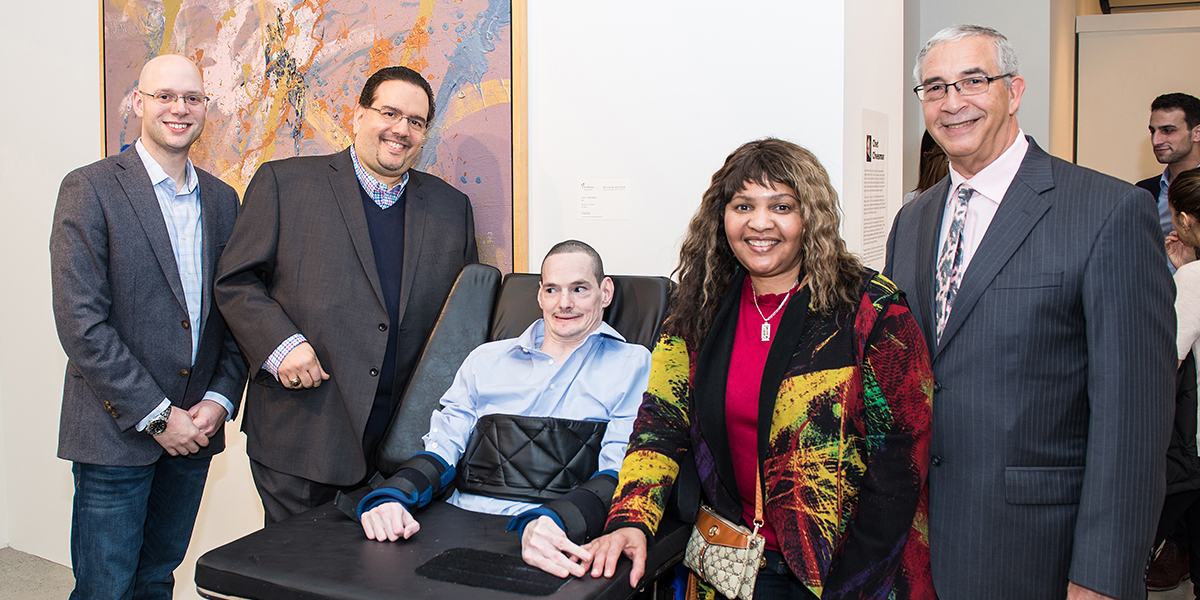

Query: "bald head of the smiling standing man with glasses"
left=133, top=54, right=208, bottom=164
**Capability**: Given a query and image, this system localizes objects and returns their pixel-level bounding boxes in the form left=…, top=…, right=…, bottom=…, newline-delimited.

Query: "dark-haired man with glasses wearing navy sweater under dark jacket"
left=216, top=67, right=478, bottom=523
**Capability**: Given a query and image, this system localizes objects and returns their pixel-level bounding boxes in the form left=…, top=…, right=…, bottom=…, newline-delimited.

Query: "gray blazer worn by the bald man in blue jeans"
left=50, top=146, right=246, bottom=467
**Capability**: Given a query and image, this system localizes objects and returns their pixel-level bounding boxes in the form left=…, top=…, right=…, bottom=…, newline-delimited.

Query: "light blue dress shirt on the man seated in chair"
left=421, top=319, right=650, bottom=515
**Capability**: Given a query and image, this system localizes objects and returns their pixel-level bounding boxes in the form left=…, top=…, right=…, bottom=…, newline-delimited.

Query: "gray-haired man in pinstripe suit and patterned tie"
left=884, top=25, right=1176, bottom=600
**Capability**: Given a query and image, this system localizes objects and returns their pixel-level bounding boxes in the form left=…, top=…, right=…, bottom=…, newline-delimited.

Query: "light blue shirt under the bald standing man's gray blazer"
left=133, top=139, right=233, bottom=431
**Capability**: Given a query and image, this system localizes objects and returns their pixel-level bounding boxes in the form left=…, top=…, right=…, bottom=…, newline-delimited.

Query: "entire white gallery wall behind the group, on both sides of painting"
left=0, top=0, right=902, bottom=598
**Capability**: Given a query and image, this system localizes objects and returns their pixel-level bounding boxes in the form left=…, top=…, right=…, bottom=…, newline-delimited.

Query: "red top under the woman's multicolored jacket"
left=725, top=277, right=796, bottom=551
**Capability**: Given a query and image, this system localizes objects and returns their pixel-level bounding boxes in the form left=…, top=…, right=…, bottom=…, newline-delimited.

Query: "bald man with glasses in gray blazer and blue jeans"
left=50, top=55, right=246, bottom=599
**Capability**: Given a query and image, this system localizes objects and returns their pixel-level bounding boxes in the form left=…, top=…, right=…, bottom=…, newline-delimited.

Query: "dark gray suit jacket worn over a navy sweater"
left=216, top=149, right=479, bottom=485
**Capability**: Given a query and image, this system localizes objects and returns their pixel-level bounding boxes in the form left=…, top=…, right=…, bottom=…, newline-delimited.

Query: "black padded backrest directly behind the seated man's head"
left=487, top=272, right=673, bottom=349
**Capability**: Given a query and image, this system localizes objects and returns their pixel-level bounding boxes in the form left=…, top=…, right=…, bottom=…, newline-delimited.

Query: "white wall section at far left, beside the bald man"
left=0, top=0, right=101, bottom=563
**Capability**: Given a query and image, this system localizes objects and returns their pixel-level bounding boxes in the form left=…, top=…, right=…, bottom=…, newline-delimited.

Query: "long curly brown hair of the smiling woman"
left=665, top=138, right=863, bottom=346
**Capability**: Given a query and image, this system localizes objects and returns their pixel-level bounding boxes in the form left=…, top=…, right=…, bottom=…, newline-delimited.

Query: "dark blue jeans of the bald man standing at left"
left=71, top=454, right=211, bottom=600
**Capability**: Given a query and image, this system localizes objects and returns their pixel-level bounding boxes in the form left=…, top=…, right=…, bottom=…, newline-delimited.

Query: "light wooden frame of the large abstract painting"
left=97, top=0, right=529, bottom=272
